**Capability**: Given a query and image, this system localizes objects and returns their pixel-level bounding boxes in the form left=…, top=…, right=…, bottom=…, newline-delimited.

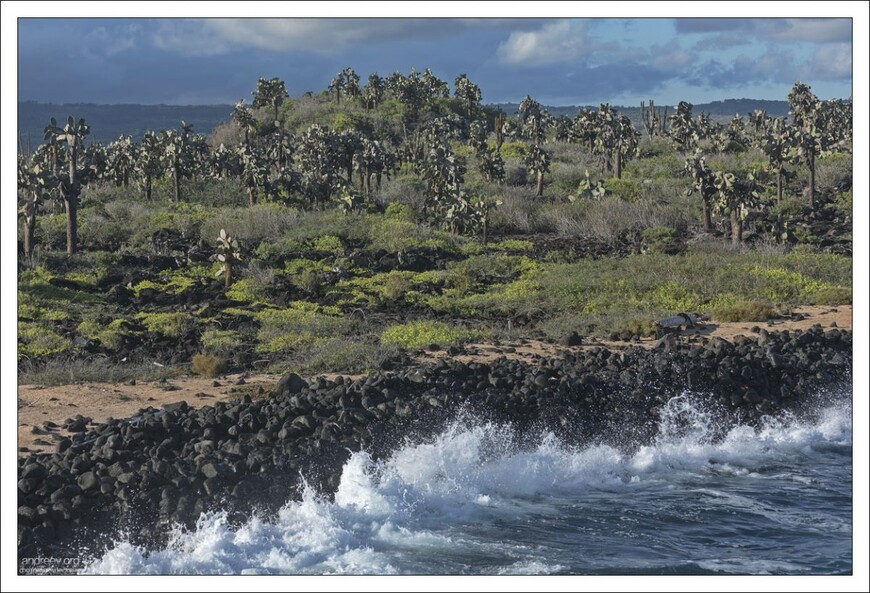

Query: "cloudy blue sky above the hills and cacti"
left=18, top=18, right=852, bottom=105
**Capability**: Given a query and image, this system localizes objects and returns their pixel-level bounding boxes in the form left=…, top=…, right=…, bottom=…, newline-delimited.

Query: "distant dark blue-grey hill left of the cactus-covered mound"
left=18, top=101, right=233, bottom=145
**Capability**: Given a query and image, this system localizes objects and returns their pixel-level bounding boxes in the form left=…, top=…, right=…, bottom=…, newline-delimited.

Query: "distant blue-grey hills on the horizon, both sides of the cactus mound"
left=18, top=99, right=788, bottom=146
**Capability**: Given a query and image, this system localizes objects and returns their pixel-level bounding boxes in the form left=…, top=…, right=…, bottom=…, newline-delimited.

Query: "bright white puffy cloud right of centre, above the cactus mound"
left=497, top=20, right=617, bottom=66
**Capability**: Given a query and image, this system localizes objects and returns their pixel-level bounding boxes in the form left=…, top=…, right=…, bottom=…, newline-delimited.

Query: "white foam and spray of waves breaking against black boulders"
left=85, top=397, right=852, bottom=574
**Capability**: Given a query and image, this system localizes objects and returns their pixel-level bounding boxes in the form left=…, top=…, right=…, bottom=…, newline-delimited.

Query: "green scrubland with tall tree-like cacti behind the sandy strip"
left=18, top=71, right=852, bottom=383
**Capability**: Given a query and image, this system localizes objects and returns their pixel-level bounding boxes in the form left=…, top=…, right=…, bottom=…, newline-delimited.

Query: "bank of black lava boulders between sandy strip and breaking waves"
left=18, top=326, right=852, bottom=556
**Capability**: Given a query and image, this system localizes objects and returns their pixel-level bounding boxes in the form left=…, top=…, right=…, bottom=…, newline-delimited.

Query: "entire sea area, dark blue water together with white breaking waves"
left=83, top=396, right=852, bottom=575
